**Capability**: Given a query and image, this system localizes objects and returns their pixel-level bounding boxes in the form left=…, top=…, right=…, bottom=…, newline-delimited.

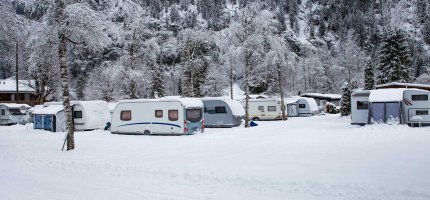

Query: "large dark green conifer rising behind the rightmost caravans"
left=377, top=30, right=412, bottom=84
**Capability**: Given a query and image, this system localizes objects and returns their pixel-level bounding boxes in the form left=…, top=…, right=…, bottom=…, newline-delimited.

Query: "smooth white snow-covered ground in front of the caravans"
left=0, top=115, right=430, bottom=200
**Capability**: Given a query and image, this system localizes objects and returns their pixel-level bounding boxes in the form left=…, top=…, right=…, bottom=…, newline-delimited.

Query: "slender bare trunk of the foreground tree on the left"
left=56, top=0, right=75, bottom=151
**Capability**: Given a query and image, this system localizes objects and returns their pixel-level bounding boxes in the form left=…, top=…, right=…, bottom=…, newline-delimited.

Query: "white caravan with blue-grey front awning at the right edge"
left=369, top=88, right=430, bottom=125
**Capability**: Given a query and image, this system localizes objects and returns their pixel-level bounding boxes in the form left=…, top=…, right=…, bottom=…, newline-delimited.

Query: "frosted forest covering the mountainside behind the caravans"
left=0, top=0, right=430, bottom=102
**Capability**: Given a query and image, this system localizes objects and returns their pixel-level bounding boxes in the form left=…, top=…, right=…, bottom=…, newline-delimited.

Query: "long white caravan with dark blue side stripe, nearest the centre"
left=111, top=97, right=204, bottom=135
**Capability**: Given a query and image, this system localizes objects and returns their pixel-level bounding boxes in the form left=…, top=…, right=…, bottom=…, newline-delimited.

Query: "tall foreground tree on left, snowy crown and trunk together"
left=32, top=0, right=108, bottom=150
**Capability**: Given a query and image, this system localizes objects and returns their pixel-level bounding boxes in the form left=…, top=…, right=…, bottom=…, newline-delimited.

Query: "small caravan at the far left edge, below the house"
left=0, top=103, right=30, bottom=125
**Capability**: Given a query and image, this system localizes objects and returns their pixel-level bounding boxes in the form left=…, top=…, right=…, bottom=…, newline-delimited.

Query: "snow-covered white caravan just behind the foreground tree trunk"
left=44, top=101, right=110, bottom=131
